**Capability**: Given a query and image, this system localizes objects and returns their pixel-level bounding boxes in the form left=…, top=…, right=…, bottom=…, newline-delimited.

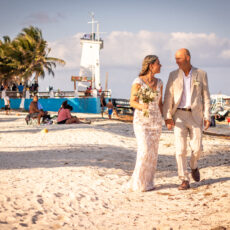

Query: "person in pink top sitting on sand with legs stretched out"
left=57, top=101, right=91, bottom=124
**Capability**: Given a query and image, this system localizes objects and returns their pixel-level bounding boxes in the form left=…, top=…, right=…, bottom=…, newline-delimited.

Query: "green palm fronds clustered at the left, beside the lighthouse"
left=0, top=26, right=65, bottom=88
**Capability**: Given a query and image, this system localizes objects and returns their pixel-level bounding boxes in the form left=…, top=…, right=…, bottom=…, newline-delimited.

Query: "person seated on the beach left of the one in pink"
left=26, top=95, right=47, bottom=125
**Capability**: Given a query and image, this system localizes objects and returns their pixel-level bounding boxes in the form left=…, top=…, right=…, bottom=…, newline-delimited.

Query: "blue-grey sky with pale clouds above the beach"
left=0, top=0, right=230, bottom=98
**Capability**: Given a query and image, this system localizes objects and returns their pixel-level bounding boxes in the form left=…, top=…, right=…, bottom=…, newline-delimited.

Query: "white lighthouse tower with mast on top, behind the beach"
left=79, top=13, right=103, bottom=90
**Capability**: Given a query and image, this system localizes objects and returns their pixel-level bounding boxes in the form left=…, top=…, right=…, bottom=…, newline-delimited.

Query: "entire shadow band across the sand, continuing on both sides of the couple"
left=0, top=144, right=230, bottom=172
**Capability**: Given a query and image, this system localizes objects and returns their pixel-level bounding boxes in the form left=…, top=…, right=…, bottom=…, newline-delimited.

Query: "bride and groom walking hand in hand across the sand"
left=128, top=48, right=210, bottom=192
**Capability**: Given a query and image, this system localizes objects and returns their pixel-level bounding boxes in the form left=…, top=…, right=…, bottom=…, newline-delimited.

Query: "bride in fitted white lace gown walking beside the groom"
left=128, top=55, right=163, bottom=192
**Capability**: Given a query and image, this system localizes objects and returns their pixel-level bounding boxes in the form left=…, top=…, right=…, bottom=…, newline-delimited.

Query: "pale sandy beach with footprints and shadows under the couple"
left=0, top=111, right=230, bottom=230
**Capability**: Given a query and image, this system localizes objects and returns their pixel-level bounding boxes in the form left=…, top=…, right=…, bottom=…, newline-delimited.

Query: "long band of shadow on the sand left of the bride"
left=0, top=145, right=135, bottom=172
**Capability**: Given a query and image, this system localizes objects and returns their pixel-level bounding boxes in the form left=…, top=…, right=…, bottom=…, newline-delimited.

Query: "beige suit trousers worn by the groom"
left=174, top=110, right=202, bottom=181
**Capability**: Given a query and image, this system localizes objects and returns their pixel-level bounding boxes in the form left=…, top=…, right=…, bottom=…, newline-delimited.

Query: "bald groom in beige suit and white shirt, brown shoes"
left=163, top=48, right=210, bottom=190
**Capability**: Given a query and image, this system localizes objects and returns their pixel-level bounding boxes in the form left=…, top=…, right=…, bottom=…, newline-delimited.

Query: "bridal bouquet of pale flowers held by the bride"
left=135, top=87, right=159, bottom=117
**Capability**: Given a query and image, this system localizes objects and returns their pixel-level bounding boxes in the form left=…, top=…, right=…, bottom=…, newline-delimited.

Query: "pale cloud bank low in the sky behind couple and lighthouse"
left=49, top=31, right=230, bottom=69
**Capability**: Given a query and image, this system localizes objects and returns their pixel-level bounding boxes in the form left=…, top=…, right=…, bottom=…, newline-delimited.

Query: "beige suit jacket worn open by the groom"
left=163, top=67, right=211, bottom=125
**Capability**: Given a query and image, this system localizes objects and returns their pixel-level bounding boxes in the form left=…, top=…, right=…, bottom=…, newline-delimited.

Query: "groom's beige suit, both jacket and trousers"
left=163, top=67, right=210, bottom=180
